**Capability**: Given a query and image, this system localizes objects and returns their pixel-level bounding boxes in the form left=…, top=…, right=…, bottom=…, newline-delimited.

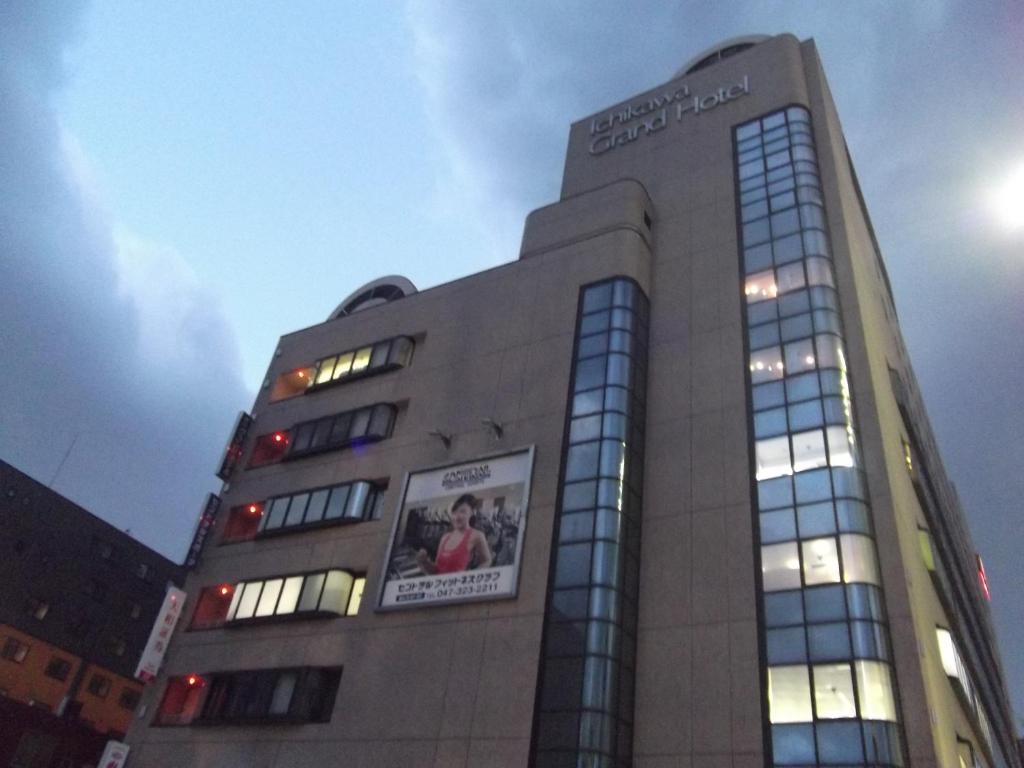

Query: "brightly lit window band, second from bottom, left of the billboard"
left=226, top=570, right=366, bottom=622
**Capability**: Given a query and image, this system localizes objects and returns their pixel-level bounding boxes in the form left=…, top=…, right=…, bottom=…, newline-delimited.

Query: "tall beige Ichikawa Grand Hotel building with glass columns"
left=128, top=35, right=1021, bottom=768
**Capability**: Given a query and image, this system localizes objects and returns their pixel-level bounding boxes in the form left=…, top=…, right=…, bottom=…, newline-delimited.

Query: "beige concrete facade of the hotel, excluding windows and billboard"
left=129, top=35, right=1018, bottom=768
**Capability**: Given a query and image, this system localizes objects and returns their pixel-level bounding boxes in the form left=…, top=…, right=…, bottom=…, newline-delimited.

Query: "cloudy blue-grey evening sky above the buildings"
left=0, top=0, right=1024, bottom=712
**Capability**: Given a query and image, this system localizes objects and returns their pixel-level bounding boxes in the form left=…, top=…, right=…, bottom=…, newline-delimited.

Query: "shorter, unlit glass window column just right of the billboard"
left=531, top=278, right=648, bottom=768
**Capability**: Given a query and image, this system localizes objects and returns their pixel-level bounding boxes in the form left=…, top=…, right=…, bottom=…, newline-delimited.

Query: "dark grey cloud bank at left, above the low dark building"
left=0, top=2, right=249, bottom=558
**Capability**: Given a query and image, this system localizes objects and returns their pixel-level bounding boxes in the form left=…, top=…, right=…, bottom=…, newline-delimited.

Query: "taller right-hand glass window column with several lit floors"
left=734, top=106, right=903, bottom=766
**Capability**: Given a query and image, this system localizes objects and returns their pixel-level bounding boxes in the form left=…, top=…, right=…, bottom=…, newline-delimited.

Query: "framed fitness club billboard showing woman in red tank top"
left=377, top=446, right=534, bottom=610
